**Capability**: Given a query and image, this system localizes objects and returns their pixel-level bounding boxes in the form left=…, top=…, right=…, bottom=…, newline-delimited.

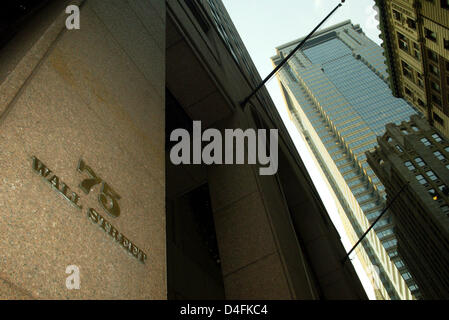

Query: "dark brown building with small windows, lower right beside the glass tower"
left=367, top=115, right=449, bottom=299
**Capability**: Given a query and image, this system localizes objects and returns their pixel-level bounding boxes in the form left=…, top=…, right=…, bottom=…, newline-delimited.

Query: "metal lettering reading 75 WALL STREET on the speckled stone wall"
left=32, top=156, right=147, bottom=263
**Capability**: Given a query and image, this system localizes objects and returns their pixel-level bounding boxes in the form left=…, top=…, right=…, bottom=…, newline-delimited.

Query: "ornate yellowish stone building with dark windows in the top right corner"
left=376, top=0, right=449, bottom=137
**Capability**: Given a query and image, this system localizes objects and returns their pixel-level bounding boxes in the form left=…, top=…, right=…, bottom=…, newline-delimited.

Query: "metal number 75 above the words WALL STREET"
left=78, top=159, right=121, bottom=217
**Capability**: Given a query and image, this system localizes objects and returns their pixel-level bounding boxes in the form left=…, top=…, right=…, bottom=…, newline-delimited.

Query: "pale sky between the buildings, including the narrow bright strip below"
left=222, top=0, right=381, bottom=299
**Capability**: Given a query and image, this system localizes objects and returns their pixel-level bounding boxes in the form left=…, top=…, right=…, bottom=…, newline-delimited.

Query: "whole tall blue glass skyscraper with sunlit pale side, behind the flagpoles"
left=272, top=21, right=416, bottom=299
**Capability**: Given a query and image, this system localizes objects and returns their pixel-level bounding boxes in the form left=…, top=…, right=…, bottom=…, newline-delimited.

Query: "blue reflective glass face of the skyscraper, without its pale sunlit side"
left=273, top=21, right=416, bottom=296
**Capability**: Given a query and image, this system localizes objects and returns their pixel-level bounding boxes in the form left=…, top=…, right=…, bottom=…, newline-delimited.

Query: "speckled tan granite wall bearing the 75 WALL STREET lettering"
left=0, top=0, right=166, bottom=299
